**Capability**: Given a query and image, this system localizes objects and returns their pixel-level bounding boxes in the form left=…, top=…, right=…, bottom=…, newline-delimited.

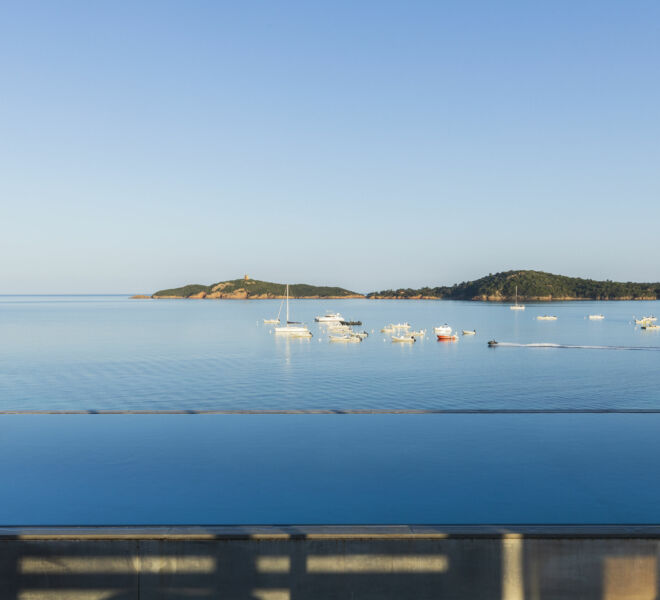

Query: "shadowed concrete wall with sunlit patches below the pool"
left=0, top=526, right=660, bottom=600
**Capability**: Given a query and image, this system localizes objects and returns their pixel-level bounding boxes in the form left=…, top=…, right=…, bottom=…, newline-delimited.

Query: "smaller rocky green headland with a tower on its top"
left=139, top=275, right=364, bottom=300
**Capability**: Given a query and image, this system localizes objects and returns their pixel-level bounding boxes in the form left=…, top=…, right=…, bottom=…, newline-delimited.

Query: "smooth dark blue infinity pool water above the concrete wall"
left=0, top=414, right=660, bottom=525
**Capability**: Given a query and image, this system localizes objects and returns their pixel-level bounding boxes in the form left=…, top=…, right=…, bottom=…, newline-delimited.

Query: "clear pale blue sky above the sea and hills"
left=0, top=0, right=660, bottom=294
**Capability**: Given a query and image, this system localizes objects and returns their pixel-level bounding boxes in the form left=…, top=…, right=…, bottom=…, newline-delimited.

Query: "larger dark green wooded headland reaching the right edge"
left=366, top=271, right=660, bottom=302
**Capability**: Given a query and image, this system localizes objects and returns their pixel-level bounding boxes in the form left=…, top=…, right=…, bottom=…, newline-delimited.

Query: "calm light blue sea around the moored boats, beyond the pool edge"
left=0, top=296, right=660, bottom=410
